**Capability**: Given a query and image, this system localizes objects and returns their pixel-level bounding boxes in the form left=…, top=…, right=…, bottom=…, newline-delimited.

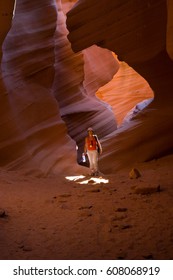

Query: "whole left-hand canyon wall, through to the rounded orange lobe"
left=0, top=0, right=119, bottom=174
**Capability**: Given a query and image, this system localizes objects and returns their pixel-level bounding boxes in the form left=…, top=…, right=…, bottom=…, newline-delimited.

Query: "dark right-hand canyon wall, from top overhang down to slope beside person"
left=67, top=0, right=173, bottom=172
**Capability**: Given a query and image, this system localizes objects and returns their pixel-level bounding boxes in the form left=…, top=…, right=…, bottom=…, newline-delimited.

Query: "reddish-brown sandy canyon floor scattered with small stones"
left=0, top=156, right=173, bottom=260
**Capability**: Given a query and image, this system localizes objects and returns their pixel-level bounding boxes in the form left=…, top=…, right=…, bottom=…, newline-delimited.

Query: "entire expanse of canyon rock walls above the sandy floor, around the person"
left=0, top=0, right=173, bottom=174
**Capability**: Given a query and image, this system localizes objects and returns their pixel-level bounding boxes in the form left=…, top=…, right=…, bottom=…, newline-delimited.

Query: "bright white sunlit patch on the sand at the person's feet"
left=66, top=175, right=109, bottom=185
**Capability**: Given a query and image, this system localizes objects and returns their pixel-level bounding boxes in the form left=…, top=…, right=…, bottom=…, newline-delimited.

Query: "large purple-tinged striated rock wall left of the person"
left=0, top=0, right=85, bottom=173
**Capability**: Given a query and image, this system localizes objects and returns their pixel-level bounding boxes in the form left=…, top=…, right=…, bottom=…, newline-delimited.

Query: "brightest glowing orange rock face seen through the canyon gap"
left=96, top=53, right=154, bottom=128
